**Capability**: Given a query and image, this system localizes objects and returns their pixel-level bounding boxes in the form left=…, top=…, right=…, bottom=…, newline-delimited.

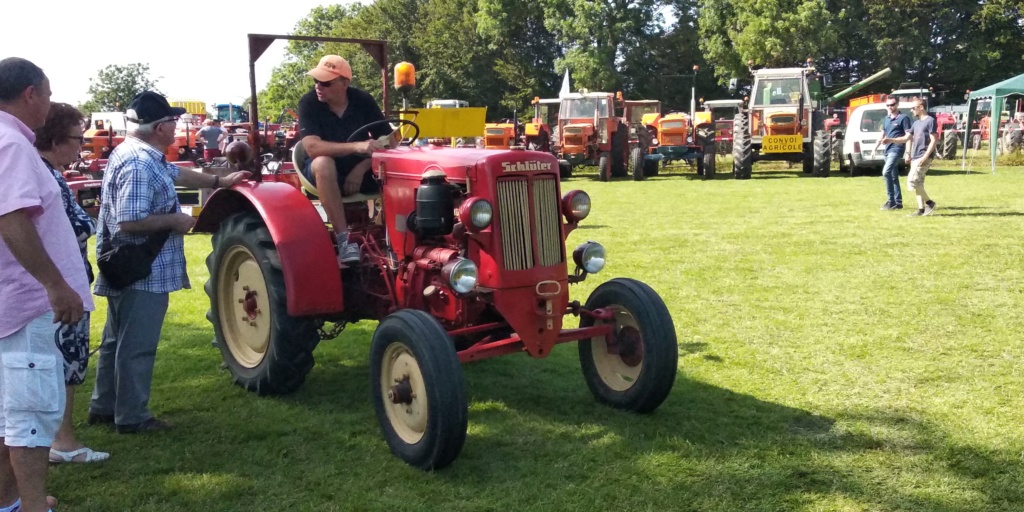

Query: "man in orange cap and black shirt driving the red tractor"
left=299, top=55, right=398, bottom=266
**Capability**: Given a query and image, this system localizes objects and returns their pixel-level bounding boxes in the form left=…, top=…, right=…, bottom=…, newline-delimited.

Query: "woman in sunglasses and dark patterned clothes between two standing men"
left=36, top=103, right=111, bottom=463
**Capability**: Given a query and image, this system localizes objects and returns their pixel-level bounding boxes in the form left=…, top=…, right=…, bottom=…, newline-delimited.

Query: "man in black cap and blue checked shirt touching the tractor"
left=89, top=91, right=249, bottom=433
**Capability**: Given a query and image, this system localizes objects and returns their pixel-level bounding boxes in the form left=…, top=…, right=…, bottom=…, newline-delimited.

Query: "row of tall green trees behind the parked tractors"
left=81, top=0, right=1024, bottom=119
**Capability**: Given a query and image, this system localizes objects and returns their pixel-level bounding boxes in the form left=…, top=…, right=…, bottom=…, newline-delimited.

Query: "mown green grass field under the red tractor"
left=50, top=159, right=1024, bottom=512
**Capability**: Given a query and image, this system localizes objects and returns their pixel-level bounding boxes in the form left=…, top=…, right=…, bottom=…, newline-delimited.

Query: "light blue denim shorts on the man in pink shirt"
left=0, top=311, right=65, bottom=447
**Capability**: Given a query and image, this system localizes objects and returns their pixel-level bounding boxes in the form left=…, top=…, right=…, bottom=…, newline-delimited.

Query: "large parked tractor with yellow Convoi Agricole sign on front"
left=732, top=66, right=892, bottom=179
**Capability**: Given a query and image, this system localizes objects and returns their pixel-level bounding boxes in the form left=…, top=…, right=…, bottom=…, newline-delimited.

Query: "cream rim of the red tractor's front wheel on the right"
left=591, top=306, right=643, bottom=391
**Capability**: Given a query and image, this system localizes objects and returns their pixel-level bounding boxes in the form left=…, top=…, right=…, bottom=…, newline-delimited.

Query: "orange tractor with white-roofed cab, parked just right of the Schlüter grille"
left=556, top=90, right=630, bottom=181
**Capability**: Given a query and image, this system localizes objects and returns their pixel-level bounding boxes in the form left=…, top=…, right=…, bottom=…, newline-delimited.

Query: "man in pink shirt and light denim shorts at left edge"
left=0, top=57, right=92, bottom=512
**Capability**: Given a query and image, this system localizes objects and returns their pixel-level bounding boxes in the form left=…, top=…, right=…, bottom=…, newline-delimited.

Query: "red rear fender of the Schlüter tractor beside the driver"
left=193, top=181, right=342, bottom=316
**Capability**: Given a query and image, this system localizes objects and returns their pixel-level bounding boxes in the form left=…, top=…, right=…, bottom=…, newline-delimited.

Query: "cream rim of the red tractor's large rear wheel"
left=217, top=246, right=271, bottom=369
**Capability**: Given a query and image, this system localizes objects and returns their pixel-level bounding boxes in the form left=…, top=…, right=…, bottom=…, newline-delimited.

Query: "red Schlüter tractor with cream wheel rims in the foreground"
left=195, top=35, right=678, bottom=470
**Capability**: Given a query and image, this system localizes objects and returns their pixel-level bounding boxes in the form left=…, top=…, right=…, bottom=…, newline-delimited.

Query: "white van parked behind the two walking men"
left=840, top=101, right=913, bottom=175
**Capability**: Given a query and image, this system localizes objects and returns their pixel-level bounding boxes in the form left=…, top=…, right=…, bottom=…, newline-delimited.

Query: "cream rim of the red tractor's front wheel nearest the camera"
left=381, top=342, right=428, bottom=444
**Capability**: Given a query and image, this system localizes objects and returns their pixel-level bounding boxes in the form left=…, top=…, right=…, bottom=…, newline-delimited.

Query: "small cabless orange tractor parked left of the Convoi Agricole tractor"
left=657, top=112, right=715, bottom=179
